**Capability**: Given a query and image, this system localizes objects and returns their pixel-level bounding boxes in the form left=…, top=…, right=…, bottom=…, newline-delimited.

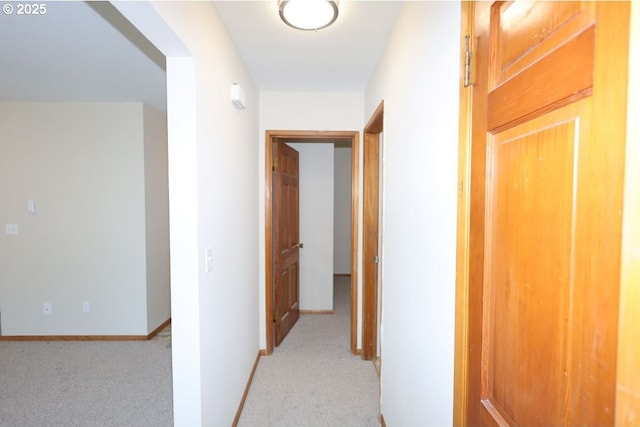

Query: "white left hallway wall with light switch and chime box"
left=114, top=1, right=264, bottom=426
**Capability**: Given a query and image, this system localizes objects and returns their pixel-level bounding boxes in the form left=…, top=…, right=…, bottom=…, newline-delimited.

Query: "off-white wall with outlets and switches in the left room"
left=0, top=102, right=169, bottom=335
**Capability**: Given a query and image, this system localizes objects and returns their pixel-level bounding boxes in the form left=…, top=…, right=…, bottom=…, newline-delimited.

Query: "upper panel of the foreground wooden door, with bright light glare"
left=489, top=1, right=594, bottom=90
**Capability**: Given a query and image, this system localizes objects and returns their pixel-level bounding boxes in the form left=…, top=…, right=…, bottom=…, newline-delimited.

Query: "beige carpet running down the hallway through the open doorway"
left=238, top=277, right=380, bottom=427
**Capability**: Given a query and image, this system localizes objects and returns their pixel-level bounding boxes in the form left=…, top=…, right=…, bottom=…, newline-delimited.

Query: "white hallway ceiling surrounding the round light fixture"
left=214, top=0, right=402, bottom=92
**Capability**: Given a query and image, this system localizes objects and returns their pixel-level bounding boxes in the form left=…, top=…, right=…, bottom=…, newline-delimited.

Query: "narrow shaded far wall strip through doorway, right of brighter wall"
left=333, top=148, right=351, bottom=274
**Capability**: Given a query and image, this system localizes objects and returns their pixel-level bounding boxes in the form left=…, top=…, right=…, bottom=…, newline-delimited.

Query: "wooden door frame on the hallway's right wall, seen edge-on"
left=362, top=100, right=384, bottom=360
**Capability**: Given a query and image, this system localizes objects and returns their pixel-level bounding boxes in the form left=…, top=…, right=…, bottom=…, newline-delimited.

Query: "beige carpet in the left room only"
left=0, top=332, right=173, bottom=427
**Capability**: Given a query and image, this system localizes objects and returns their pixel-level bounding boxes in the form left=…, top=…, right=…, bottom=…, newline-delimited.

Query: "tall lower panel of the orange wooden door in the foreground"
left=482, top=101, right=588, bottom=427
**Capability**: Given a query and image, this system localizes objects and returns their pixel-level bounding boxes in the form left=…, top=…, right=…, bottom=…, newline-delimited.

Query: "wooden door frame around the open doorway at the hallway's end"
left=264, top=130, right=360, bottom=355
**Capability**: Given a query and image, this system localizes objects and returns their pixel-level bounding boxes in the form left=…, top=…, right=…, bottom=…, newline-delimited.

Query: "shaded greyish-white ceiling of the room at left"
left=0, top=1, right=166, bottom=109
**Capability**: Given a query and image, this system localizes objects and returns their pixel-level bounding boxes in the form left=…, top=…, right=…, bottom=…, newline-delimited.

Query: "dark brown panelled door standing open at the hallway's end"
left=273, top=141, right=300, bottom=346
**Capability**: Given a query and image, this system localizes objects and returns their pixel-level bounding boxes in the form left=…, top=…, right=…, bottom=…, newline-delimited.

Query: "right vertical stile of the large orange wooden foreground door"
left=567, top=2, right=629, bottom=426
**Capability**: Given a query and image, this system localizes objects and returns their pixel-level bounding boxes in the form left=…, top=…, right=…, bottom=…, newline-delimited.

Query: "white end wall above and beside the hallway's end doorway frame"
left=258, top=92, right=364, bottom=349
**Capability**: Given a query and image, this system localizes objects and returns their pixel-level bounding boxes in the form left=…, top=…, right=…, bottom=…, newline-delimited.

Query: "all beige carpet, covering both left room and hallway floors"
left=0, top=278, right=380, bottom=427
